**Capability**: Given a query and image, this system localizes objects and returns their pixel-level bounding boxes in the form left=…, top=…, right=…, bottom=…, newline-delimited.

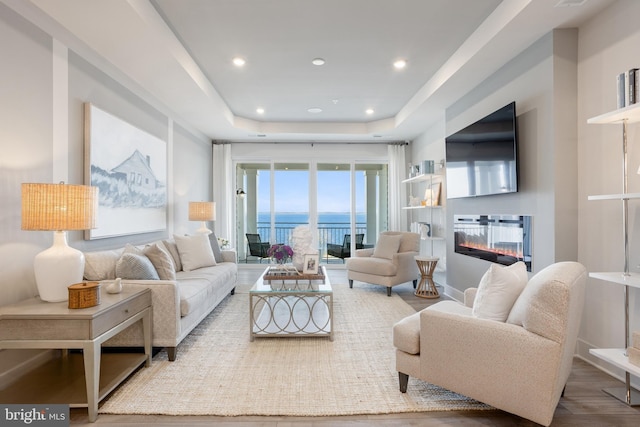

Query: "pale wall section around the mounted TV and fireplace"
left=420, top=29, right=577, bottom=294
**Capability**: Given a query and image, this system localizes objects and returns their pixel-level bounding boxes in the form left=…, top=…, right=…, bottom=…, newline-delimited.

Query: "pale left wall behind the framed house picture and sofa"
left=0, top=4, right=213, bottom=386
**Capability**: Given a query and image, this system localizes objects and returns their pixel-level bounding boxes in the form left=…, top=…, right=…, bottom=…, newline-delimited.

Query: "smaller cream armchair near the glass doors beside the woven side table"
left=347, top=231, right=420, bottom=296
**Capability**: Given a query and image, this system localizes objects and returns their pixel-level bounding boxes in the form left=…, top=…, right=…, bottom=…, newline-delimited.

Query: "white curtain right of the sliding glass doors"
left=388, top=144, right=409, bottom=231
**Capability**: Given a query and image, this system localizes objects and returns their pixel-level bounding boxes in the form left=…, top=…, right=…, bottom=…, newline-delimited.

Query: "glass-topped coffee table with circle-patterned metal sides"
left=249, top=266, right=333, bottom=341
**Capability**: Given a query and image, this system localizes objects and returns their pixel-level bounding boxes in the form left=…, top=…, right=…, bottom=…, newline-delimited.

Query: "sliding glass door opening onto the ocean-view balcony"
left=236, top=162, right=387, bottom=263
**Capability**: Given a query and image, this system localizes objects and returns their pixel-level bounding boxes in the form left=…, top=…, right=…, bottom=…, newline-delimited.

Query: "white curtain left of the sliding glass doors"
left=212, top=143, right=236, bottom=242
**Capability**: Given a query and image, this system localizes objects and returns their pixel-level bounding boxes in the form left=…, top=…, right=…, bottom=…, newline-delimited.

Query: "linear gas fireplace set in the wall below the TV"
left=453, top=215, right=532, bottom=271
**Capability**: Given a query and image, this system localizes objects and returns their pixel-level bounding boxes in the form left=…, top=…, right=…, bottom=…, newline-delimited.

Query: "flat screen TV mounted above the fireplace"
left=445, top=102, right=518, bottom=199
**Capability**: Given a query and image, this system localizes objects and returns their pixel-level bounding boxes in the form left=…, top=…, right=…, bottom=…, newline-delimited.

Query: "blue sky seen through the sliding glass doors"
left=258, top=171, right=365, bottom=213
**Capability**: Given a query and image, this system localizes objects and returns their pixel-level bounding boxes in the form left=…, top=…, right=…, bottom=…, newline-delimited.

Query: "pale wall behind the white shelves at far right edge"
left=577, top=0, right=640, bottom=374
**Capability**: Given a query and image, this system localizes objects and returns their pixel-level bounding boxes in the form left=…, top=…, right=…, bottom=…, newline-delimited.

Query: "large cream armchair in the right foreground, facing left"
left=393, top=262, right=586, bottom=426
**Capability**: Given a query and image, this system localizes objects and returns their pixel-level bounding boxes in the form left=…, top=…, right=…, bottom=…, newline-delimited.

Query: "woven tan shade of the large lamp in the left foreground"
left=22, top=183, right=98, bottom=231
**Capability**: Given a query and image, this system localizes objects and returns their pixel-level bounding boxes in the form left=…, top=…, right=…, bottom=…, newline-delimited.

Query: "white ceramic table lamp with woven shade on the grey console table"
left=22, top=182, right=98, bottom=302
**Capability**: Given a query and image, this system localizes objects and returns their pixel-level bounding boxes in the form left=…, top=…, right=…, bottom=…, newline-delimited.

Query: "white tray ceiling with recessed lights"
left=6, top=0, right=611, bottom=142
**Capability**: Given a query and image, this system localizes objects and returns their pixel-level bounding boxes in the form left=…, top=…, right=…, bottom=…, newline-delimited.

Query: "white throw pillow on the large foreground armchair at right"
left=471, top=261, right=529, bottom=322
